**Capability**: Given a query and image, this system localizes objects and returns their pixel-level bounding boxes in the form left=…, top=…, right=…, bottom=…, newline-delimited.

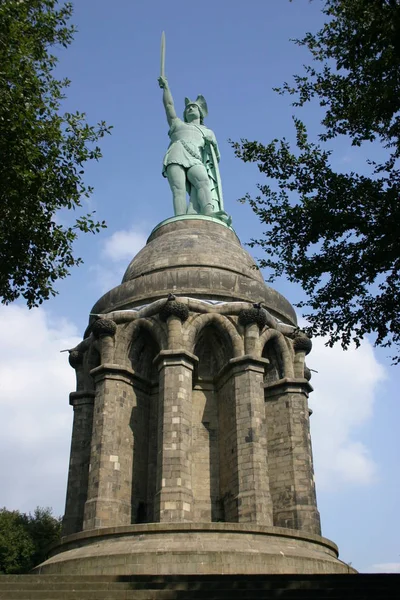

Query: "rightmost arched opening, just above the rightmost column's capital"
left=260, top=329, right=294, bottom=383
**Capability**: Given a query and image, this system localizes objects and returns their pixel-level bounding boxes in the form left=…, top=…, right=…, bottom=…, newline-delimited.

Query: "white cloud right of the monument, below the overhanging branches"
left=307, top=338, right=386, bottom=489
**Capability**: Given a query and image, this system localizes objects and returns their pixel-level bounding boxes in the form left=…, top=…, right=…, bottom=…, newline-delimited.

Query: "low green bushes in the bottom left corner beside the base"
left=0, top=507, right=61, bottom=574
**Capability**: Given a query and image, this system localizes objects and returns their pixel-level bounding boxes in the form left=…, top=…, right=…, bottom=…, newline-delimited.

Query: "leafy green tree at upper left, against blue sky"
left=0, top=0, right=110, bottom=308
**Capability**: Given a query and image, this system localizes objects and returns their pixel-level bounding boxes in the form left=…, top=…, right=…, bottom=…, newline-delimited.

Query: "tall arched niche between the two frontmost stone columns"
left=192, top=320, right=233, bottom=522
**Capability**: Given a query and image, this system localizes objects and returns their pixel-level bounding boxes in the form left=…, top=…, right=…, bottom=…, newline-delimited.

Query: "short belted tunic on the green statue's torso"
left=162, top=117, right=212, bottom=177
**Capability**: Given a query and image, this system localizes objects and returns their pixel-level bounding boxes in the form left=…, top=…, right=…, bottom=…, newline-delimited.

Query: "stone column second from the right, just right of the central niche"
left=229, top=355, right=272, bottom=525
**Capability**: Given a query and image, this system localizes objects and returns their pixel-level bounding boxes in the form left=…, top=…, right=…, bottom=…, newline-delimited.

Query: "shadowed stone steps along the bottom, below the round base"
left=0, top=574, right=400, bottom=600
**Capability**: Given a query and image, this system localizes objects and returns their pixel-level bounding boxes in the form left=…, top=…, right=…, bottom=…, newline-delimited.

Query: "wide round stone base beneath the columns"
left=34, top=523, right=356, bottom=575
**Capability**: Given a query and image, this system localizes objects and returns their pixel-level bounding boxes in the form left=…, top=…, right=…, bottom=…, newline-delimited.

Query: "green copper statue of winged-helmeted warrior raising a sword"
left=158, top=34, right=231, bottom=225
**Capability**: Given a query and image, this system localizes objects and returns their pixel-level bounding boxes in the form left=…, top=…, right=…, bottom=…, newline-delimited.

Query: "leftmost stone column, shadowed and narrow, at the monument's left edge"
left=62, top=390, right=95, bottom=536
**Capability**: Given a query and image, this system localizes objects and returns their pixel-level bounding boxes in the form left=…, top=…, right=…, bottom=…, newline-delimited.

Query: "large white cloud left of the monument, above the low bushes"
left=0, top=305, right=80, bottom=514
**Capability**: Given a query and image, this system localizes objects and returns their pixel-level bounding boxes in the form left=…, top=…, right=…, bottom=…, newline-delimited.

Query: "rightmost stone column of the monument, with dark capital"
left=265, top=378, right=321, bottom=535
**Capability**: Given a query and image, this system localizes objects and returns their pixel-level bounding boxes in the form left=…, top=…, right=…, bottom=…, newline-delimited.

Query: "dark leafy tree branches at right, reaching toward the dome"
left=232, top=0, right=400, bottom=363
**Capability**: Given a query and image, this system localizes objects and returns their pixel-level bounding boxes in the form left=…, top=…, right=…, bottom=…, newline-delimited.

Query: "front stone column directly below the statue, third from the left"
left=154, top=350, right=198, bottom=522
